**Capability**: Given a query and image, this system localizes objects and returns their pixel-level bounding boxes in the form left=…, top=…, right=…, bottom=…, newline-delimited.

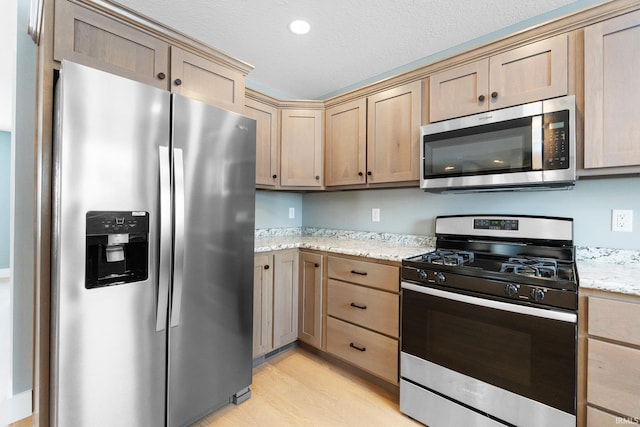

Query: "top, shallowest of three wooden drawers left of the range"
left=328, top=256, right=400, bottom=292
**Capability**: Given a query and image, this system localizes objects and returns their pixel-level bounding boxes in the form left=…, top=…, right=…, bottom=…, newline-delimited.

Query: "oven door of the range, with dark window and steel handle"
left=400, top=282, right=577, bottom=426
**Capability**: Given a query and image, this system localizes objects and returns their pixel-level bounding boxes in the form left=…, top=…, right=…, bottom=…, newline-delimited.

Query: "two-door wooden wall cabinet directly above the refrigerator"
left=53, top=0, right=251, bottom=113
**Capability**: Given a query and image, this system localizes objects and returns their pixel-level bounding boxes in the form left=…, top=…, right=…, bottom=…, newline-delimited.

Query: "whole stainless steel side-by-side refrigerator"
left=51, top=61, right=256, bottom=427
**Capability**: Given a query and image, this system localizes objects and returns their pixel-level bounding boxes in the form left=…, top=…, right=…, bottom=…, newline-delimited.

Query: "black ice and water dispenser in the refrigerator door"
left=85, top=211, right=149, bottom=289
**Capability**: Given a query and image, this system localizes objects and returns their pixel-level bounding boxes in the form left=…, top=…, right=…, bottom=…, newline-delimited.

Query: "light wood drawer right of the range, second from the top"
left=587, top=339, right=640, bottom=418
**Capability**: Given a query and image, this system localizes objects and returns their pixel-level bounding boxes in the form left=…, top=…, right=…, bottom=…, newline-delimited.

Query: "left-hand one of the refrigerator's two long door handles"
left=156, top=146, right=171, bottom=332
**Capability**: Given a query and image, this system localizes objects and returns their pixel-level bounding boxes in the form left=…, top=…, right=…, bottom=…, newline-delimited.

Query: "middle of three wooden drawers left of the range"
left=327, top=279, right=400, bottom=337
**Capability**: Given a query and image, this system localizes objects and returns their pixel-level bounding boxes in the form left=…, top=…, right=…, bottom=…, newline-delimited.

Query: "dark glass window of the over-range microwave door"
left=423, top=117, right=540, bottom=179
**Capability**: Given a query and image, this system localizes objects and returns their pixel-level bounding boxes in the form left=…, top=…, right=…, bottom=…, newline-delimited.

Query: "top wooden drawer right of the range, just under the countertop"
left=588, top=297, right=640, bottom=345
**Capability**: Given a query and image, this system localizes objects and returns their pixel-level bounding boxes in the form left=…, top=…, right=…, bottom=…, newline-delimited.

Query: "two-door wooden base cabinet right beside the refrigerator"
left=253, top=250, right=298, bottom=358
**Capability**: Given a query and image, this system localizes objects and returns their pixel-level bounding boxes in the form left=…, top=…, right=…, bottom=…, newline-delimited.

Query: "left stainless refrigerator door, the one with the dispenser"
left=51, top=61, right=171, bottom=427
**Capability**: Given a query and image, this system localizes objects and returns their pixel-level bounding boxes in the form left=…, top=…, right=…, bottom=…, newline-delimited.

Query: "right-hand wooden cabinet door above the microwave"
left=488, top=34, right=569, bottom=109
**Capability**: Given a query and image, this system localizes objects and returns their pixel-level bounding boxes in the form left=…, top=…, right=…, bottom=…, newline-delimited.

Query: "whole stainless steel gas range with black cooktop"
left=400, top=215, right=578, bottom=427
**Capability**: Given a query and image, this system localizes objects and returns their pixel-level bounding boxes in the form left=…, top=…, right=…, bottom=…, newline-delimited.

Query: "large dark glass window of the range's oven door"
left=402, top=289, right=576, bottom=414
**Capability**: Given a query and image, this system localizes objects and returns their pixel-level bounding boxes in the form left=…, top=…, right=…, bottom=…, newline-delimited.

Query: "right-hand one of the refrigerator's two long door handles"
left=171, top=148, right=184, bottom=328
